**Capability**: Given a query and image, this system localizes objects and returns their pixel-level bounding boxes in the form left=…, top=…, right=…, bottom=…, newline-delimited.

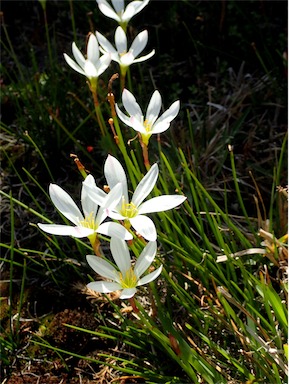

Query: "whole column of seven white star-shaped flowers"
left=38, top=0, right=186, bottom=299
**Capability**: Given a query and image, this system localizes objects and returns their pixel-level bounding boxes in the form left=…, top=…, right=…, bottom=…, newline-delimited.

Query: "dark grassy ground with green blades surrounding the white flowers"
left=0, top=0, right=287, bottom=384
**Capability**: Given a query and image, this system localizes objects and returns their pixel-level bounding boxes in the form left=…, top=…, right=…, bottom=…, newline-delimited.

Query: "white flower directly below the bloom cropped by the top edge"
left=96, top=27, right=155, bottom=74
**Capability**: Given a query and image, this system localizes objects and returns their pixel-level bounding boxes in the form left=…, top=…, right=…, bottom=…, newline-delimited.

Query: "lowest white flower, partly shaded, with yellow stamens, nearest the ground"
left=86, top=237, right=162, bottom=299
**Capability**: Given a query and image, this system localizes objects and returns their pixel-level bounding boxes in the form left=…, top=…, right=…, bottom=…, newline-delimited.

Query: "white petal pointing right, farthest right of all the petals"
left=138, top=195, right=186, bottom=214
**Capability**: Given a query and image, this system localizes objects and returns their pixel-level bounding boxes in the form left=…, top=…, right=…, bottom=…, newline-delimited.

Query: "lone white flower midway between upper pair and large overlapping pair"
left=116, top=89, right=180, bottom=145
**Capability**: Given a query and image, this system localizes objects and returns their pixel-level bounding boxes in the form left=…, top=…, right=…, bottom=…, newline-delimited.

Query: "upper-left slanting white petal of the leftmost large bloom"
left=49, top=184, right=83, bottom=225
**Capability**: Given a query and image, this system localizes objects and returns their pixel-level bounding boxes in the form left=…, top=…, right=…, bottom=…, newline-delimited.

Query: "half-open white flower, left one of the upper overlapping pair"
left=64, top=34, right=111, bottom=81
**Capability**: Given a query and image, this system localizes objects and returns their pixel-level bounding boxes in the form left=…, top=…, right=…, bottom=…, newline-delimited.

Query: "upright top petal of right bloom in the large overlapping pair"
left=104, top=155, right=128, bottom=201
